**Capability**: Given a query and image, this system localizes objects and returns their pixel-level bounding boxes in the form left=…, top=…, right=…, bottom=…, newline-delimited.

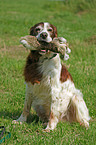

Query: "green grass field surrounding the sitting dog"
left=0, top=0, right=96, bottom=145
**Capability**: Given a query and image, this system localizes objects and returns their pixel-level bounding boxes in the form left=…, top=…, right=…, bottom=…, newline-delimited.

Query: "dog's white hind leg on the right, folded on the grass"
left=67, top=89, right=90, bottom=128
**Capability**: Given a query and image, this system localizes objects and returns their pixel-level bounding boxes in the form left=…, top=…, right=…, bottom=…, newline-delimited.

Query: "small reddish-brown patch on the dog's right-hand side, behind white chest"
left=60, top=65, right=73, bottom=83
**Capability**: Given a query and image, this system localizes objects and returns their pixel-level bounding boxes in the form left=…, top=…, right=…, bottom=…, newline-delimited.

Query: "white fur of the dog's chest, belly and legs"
left=17, top=53, right=90, bottom=130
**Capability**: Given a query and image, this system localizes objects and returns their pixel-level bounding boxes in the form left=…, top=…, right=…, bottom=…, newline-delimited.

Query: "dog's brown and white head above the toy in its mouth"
left=30, top=22, right=57, bottom=43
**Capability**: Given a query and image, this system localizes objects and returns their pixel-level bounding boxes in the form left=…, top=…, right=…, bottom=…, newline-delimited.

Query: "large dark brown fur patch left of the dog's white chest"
left=24, top=51, right=42, bottom=84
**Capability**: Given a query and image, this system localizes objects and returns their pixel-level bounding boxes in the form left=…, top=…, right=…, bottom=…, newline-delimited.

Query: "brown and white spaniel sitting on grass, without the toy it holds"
left=16, top=22, right=90, bottom=131
